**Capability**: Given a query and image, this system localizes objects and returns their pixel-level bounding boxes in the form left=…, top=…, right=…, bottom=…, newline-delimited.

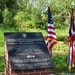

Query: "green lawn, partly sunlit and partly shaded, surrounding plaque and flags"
left=0, top=27, right=75, bottom=75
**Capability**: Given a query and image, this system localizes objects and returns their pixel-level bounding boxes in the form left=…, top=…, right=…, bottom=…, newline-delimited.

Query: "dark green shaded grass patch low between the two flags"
left=52, top=54, right=67, bottom=70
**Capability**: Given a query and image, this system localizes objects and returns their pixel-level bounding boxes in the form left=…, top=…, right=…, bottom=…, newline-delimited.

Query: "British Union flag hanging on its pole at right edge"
left=68, top=9, right=75, bottom=71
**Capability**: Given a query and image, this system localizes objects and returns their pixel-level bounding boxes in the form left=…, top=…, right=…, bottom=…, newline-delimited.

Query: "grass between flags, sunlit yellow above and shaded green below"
left=53, top=41, right=69, bottom=70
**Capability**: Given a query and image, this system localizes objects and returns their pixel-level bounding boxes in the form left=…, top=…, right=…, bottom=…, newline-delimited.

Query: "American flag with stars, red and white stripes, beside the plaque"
left=46, top=7, right=57, bottom=57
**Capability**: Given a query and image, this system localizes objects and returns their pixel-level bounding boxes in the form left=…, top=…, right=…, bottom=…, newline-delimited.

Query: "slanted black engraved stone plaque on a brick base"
left=4, top=32, right=54, bottom=70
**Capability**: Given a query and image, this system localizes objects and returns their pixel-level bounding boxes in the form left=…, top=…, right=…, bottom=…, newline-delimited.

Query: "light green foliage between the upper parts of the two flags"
left=50, top=0, right=72, bottom=29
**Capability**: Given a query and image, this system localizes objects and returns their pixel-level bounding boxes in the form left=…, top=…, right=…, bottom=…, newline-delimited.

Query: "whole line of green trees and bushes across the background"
left=0, top=0, right=72, bottom=29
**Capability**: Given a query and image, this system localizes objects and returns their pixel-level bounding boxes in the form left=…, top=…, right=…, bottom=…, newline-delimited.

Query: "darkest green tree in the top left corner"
left=0, top=0, right=17, bottom=23
